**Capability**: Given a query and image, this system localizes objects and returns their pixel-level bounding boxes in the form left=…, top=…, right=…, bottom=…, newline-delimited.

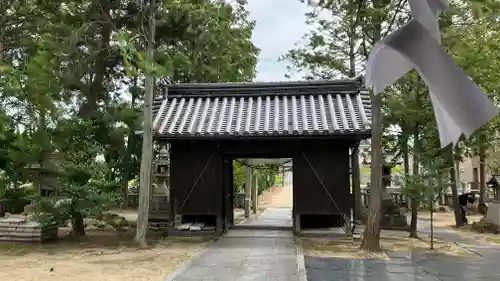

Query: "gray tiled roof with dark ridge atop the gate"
left=153, top=79, right=371, bottom=138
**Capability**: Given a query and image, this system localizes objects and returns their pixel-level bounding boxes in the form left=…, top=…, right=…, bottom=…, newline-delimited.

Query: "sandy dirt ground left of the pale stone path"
left=0, top=211, right=208, bottom=281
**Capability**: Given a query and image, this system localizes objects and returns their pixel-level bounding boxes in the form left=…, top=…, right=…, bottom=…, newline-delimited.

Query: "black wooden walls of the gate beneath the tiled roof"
left=170, top=139, right=357, bottom=223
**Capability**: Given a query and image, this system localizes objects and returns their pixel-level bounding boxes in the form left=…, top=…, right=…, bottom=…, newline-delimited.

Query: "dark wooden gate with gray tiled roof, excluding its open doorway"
left=153, top=78, right=371, bottom=233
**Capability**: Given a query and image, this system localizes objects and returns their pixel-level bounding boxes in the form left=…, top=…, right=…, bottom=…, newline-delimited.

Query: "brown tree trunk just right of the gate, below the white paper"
left=361, top=92, right=382, bottom=252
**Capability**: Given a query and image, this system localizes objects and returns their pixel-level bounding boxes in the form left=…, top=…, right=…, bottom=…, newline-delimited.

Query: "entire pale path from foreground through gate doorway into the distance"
left=167, top=185, right=306, bottom=281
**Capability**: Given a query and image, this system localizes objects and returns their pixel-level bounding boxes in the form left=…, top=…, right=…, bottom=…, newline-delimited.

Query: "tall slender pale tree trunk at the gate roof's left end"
left=135, top=0, right=156, bottom=248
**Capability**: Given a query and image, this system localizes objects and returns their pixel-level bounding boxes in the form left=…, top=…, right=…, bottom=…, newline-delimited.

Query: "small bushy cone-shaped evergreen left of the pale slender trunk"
left=29, top=126, right=121, bottom=236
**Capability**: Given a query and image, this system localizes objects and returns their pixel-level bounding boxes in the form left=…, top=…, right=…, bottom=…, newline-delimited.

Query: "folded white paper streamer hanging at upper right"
left=366, top=0, right=498, bottom=147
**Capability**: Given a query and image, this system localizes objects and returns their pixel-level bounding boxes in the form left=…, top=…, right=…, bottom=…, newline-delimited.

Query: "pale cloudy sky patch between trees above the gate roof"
left=248, top=0, right=308, bottom=81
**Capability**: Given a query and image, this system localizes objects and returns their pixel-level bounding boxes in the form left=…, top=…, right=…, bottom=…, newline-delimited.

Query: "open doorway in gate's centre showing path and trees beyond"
left=229, top=158, right=294, bottom=230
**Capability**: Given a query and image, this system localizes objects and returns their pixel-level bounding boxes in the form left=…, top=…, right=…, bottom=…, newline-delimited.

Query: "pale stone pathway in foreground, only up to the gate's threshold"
left=167, top=230, right=301, bottom=281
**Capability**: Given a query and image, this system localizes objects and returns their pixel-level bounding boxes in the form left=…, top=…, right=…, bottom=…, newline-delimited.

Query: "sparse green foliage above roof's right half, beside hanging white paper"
left=282, top=0, right=409, bottom=79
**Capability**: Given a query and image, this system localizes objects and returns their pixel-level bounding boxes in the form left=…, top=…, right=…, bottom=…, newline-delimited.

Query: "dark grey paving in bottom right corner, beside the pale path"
left=304, top=252, right=500, bottom=281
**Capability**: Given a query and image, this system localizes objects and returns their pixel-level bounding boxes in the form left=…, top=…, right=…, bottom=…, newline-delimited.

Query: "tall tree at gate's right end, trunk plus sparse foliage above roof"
left=284, top=0, right=408, bottom=251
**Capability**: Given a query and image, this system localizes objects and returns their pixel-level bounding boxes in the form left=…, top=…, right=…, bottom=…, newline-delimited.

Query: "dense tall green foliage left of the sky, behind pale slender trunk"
left=0, top=0, right=258, bottom=210
